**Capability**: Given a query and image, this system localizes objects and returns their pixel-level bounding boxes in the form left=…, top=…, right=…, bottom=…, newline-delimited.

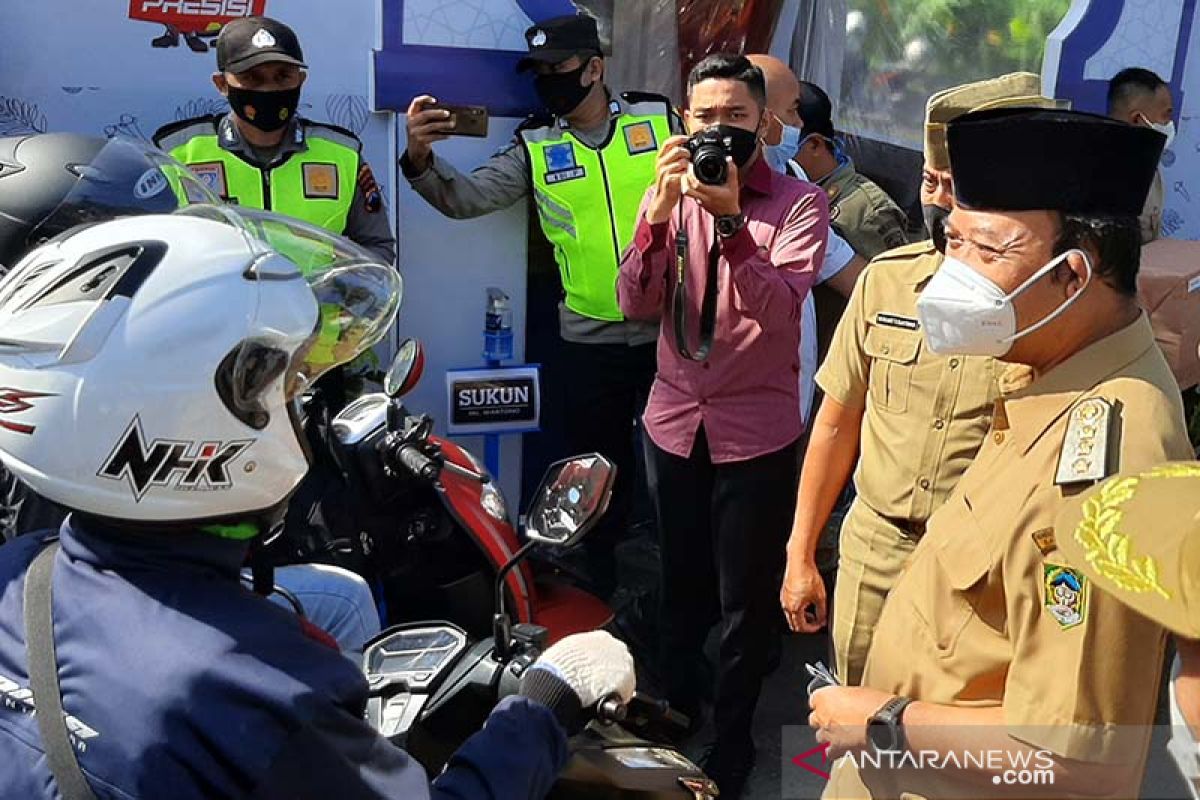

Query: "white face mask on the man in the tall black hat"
left=917, top=249, right=1092, bottom=357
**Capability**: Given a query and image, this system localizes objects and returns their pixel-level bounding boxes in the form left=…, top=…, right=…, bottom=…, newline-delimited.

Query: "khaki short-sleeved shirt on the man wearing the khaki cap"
left=817, top=241, right=996, bottom=522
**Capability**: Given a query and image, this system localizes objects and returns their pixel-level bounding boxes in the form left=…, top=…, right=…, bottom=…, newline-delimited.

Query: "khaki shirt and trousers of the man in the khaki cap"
left=816, top=241, right=996, bottom=685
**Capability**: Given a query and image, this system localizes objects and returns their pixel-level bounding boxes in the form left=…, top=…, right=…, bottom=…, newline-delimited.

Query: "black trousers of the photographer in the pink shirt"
left=646, top=428, right=797, bottom=750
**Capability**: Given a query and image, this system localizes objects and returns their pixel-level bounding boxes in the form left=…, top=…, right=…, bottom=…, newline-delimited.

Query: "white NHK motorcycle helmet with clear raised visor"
left=0, top=206, right=401, bottom=522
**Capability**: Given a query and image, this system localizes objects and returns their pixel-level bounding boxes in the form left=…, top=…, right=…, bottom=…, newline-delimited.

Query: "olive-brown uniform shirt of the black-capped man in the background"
left=817, top=158, right=908, bottom=260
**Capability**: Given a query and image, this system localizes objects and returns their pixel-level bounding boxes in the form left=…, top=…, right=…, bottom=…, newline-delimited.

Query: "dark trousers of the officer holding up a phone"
left=558, top=342, right=656, bottom=596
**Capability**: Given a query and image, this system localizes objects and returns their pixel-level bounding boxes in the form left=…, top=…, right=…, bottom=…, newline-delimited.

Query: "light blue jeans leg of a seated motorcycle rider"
left=248, top=564, right=379, bottom=658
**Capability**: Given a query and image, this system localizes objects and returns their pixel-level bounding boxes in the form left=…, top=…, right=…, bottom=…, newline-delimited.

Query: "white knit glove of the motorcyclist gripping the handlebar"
left=534, top=631, right=637, bottom=708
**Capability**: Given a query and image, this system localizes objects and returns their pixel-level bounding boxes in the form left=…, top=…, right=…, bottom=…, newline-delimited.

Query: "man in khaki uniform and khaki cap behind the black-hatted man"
left=780, top=73, right=1051, bottom=684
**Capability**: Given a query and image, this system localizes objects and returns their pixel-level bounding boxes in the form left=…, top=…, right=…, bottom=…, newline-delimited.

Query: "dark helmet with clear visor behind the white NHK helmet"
left=0, top=133, right=220, bottom=267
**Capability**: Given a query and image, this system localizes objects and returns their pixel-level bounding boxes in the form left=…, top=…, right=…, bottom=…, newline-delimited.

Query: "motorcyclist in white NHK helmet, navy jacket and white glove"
left=0, top=209, right=634, bottom=800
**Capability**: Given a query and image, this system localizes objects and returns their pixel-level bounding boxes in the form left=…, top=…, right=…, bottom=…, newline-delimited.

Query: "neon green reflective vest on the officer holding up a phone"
left=520, top=94, right=671, bottom=321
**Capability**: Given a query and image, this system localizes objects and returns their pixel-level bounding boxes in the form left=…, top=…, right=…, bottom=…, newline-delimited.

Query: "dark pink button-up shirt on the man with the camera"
left=617, top=158, right=829, bottom=463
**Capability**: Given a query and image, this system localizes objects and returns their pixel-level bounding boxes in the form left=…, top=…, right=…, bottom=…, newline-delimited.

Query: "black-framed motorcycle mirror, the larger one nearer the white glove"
left=526, top=453, right=617, bottom=547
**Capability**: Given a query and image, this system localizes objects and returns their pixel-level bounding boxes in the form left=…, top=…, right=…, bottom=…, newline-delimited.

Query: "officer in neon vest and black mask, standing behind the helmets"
left=154, top=17, right=396, bottom=264
